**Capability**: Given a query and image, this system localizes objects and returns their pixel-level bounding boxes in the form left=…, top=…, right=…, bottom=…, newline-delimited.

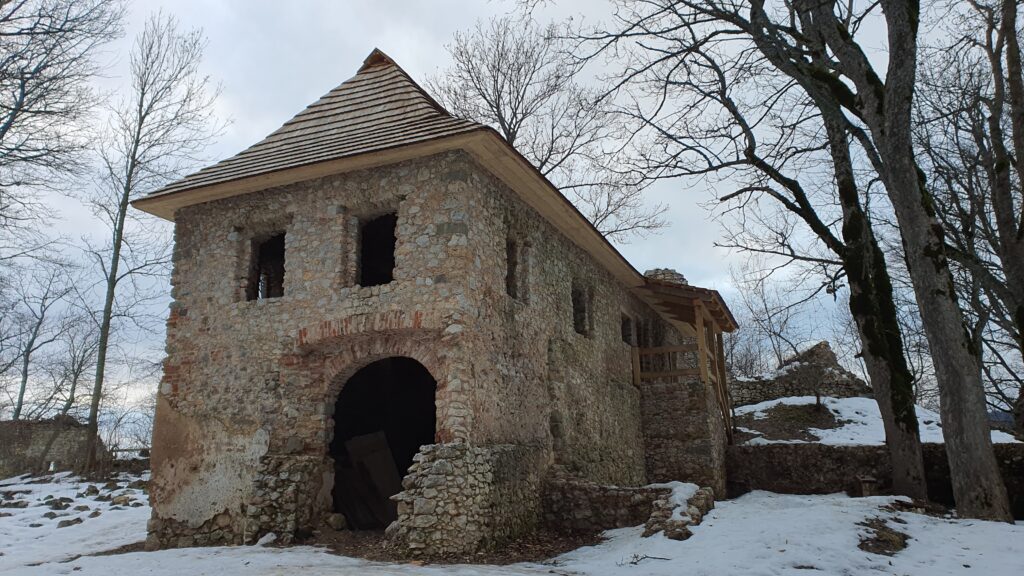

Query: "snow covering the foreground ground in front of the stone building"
left=0, top=477, right=1024, bottom=576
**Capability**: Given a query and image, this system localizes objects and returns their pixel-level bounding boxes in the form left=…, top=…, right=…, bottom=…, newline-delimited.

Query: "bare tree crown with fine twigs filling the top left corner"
left=0, top=0, right=124, bottom=243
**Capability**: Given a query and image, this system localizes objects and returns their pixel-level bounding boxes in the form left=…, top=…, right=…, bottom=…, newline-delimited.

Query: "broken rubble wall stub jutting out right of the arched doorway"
left=388, top=443, right=544, bottom=557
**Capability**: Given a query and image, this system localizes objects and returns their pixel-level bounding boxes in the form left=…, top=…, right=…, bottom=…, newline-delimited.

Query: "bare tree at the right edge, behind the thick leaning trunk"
left=914, top=0, right=1024, bottom=430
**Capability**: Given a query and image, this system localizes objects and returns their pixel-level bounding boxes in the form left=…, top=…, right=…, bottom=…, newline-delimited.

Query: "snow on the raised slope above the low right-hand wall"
left=735, top=396, right=1019, bottom=446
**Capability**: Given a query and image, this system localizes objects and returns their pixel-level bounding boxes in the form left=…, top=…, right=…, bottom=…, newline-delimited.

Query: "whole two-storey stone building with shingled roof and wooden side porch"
left=134, top=50, right=735, bottom=553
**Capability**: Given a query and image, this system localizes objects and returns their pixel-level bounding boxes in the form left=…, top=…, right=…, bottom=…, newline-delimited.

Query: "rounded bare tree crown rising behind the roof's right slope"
left=428, top=15, right=666, bottom=241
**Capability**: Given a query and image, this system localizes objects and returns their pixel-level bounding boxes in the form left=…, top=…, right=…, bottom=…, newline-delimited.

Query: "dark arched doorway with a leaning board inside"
left=330, top=357, right=437, bottom=530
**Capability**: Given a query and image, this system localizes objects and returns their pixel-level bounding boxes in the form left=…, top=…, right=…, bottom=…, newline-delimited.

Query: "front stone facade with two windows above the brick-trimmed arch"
left=151, top=150, right=487, bottom=546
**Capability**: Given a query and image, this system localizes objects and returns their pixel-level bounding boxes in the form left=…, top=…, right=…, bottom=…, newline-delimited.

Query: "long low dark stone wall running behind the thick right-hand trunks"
left=726, top=444, right=1024, bottom=520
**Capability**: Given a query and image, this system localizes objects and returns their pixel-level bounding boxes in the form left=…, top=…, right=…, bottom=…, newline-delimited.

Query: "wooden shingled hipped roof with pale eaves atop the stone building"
left=132, top=49, right=736, bottom=331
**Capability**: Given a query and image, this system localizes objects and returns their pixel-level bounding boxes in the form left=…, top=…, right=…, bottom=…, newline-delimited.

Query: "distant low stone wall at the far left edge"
left=0, top=417, right=110, bottom=478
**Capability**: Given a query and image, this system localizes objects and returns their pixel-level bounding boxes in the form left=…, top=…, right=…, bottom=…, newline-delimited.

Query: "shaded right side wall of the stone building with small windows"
left=469, top=161, right=676, bottom=486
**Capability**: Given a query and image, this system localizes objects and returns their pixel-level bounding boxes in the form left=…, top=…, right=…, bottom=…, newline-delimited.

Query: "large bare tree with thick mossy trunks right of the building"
left=591, top=0, right=1011, bottom=520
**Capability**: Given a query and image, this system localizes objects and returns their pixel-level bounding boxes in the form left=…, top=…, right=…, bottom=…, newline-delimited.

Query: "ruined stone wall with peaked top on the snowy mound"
left=729, top=342, right=871, bottom=406
